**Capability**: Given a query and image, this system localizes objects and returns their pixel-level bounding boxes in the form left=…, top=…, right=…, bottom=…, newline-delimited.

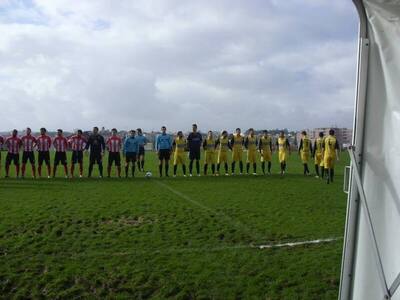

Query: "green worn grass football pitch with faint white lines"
left=0, top=153, right=348, bottom=299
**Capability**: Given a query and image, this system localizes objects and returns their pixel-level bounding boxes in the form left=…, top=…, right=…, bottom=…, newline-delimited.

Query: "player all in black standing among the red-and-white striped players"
left=85, top=127, right=106, bottom=178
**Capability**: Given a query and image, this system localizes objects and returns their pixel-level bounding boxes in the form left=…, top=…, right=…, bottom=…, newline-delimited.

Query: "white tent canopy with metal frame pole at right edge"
left=339, top=0, right=400, bottom=300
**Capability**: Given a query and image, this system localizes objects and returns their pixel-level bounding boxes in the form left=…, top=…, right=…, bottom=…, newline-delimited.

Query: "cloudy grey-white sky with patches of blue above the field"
left=0, top=0, right=358, bottom=131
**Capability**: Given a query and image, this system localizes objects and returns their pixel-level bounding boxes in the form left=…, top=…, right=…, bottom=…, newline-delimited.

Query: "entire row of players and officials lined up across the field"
left=0, top=124, right=339, bottom=183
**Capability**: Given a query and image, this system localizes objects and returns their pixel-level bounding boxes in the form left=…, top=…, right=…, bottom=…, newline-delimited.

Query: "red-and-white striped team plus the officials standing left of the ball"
left=0, top=127, right=146, bottom=178
